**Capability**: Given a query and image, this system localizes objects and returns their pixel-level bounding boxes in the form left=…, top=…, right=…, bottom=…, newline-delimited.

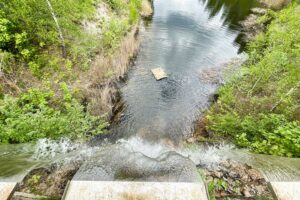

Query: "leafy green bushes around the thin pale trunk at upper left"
left=0, top=0, right=97, bottom=76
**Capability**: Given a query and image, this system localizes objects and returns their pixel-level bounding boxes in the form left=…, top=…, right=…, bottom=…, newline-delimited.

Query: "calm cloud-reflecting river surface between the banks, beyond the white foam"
left=113, top=0, right=257, bottom=143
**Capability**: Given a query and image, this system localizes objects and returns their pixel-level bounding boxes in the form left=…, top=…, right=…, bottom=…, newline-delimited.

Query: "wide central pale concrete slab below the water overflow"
left=64, top=181, right=208, bottom=200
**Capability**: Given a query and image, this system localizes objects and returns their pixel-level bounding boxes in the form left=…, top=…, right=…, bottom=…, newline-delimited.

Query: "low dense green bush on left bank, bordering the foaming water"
left=0, top=87, right=107, bottom=143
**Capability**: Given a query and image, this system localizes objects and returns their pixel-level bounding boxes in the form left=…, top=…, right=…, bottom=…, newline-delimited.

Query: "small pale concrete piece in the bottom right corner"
left=271, top=182, right=300, bottom=200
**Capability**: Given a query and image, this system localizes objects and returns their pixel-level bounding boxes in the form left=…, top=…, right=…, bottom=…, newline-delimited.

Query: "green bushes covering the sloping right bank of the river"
left=206, top=3, right=300, bottom=157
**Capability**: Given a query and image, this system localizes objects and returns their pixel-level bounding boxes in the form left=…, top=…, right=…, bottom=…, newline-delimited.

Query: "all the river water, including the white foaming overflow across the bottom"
left=0, top=0, right=300, bottom=182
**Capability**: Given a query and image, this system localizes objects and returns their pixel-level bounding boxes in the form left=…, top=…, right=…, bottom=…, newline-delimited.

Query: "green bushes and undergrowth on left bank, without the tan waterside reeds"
left=0, top=0, right=147, bottom=143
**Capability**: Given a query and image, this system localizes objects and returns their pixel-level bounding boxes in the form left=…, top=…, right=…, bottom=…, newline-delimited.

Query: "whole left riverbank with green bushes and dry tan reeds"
left=0, top=0, right=153, bottom=143
